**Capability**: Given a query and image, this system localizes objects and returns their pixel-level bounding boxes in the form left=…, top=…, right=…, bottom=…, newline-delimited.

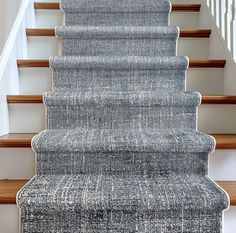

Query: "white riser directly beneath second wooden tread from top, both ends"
left=28, top=36, right=209, bottom=59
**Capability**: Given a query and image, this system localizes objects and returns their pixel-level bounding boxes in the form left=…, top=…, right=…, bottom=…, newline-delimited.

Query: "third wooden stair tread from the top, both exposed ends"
left=17, top=59, right=226, bottom=68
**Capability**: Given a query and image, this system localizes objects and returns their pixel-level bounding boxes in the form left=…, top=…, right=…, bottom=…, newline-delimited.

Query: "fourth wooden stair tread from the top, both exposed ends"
left=7, top=95, right=236, bottom=104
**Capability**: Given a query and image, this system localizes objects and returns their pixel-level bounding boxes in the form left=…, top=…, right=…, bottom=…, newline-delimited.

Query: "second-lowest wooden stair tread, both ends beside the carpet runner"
left=0, top=133, right=236, bottom=150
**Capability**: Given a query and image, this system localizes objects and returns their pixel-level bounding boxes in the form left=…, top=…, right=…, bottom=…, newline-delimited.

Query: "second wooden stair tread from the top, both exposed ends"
left=26, top=28, right=211, bottom=38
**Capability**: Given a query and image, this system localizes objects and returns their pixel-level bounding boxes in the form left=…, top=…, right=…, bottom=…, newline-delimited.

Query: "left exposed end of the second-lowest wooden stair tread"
left=0, top=133, right=35, bottom=148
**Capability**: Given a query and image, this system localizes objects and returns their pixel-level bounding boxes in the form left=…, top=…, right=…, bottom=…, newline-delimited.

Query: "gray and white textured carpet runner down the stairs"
left=18, top=0, right=228, bottom=233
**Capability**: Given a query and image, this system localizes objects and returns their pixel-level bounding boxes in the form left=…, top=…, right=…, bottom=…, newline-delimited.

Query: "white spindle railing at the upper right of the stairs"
left=206, top=0, right=236, bottom=60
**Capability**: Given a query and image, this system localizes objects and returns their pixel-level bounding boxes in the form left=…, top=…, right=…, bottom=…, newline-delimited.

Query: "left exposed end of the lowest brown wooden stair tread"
left=0, top=180, right=28, bottom=204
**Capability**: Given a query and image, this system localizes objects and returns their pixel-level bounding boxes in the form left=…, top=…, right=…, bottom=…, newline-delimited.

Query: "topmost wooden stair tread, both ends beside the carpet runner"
left=34, top=2, right=201, bottom=12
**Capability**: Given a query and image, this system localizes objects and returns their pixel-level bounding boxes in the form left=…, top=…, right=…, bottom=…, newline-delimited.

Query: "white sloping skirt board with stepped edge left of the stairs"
left=0, top=0, right=35, bottom=135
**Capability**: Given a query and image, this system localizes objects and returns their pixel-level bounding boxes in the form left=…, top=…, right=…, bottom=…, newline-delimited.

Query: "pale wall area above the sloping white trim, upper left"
left=0, top=0, right=22, bottom=53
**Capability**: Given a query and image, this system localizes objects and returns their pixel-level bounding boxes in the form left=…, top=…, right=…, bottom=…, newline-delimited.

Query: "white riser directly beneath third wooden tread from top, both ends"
left=19, top=68, right=224, bottom=95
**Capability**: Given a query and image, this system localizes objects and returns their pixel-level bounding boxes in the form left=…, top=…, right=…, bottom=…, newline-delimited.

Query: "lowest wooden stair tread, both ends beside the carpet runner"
left=0, top=180, right=236, bottom=205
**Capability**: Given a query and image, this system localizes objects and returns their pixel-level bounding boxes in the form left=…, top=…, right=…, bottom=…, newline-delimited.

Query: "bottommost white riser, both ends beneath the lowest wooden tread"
left=0, top=205, right=236, bottom=233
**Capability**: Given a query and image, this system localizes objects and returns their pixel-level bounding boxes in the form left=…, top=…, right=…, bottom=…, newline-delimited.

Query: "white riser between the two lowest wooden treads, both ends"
left=0, top=148, right=236, bottom=181
